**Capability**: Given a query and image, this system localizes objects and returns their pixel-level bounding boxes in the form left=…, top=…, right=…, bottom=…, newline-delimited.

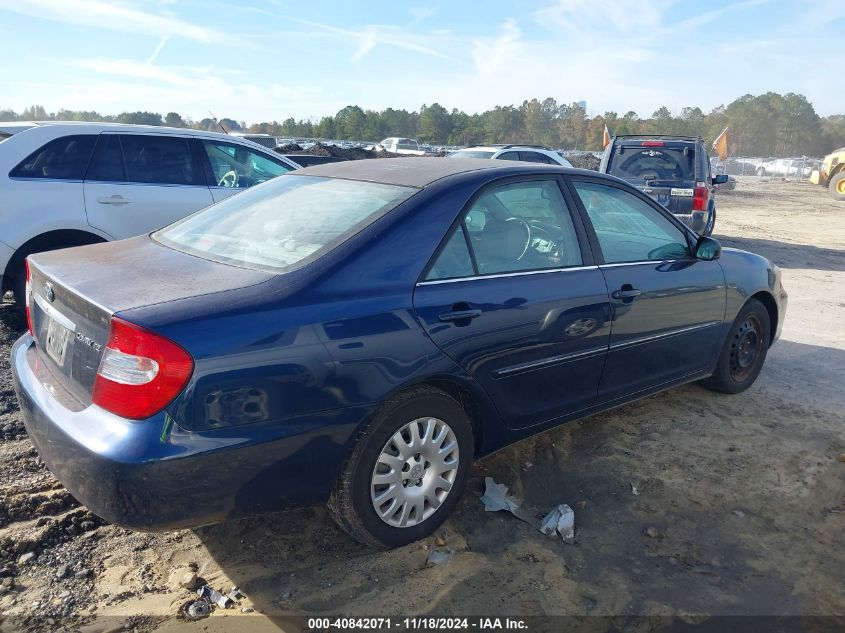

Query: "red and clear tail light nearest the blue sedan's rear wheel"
left=92, top=317, right=194, bottom=420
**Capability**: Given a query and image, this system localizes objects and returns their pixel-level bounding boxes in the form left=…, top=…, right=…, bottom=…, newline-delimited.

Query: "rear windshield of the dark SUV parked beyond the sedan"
left=608, top=146, right=695, bottom=180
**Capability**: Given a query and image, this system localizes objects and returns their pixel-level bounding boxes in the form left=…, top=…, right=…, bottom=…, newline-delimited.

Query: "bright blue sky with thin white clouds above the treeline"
left=0, top=0, right=845, bottom=123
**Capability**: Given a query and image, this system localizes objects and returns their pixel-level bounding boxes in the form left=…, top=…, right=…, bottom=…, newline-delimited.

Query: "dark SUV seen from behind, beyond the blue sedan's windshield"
left=599, top=135, right=728, bottom=235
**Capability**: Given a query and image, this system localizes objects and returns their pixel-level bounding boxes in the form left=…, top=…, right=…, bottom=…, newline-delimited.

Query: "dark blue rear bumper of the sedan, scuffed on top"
left=12, top=334, right=365, bottom=531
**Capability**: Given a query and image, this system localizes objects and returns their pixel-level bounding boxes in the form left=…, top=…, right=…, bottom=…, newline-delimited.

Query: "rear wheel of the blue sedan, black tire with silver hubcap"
left=328, top=388, right=474, bottom=549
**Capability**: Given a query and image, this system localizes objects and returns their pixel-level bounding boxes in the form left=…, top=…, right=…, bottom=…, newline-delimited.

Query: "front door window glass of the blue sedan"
left=573, top=181, right=689, bottom=264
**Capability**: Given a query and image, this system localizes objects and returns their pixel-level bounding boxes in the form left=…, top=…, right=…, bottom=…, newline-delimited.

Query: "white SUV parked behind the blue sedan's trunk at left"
left=0, top=121, right=298, bottom=306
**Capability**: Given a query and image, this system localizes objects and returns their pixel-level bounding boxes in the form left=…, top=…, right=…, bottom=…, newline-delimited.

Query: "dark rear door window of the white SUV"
left=120, top=134, right=197, bottom=185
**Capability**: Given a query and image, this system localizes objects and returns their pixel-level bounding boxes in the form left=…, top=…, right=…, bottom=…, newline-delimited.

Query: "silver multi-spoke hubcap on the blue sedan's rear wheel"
left=370, top=418, right=459, bottom=528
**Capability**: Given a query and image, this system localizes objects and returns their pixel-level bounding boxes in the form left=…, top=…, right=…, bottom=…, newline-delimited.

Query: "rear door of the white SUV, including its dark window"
left=84, top=133, right=214, bottom=239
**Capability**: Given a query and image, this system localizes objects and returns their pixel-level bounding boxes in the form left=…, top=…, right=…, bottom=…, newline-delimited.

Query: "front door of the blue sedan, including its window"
left=572, top=179, right=726, bottom=401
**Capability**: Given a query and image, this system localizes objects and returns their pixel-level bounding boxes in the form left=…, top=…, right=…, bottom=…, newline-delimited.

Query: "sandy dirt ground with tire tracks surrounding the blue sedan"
left=0, top=179, right=845, bottom=631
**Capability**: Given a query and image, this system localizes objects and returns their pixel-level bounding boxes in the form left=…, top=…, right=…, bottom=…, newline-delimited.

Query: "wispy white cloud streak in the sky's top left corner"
left=0, top=0, right=239, bottom=44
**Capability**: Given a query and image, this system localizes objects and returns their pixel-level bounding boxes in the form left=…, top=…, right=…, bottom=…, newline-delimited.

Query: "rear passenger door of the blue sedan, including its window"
left=414, top=178, right=610, bottom=428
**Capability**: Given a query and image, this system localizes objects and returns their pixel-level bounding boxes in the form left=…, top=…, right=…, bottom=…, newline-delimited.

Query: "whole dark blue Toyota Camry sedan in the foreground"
left=12, top=158, right=786, bottom=547
